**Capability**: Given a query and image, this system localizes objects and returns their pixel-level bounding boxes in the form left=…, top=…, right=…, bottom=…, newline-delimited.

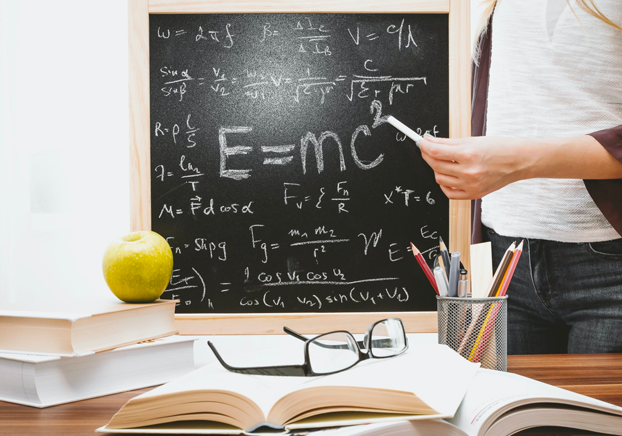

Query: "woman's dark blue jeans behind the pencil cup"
left=484, top=228, right=622, bottom=354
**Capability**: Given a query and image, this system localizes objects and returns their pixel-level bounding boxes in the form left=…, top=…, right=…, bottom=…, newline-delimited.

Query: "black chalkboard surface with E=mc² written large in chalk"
left=149, top=13, right=450, bottom=314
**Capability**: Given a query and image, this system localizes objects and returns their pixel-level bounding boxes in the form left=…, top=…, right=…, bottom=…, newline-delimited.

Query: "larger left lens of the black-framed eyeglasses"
left=309, top=332, right=359, bottom=374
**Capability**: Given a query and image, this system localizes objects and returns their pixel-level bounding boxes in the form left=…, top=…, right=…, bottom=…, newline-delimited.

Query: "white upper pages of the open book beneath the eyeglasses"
left=124, top=344, right=479, bottom=422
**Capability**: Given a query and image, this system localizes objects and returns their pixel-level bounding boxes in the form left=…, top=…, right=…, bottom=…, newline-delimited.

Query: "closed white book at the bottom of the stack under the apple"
left=0, top=336, right=195, bottom=407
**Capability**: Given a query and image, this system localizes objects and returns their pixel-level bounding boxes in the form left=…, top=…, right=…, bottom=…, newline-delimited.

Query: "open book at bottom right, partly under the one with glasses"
left=313, top=369, right=622, bottom=436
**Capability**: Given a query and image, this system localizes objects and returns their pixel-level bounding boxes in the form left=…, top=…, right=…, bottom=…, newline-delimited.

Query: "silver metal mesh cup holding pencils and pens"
left=436, top=296, right=508, bottom=371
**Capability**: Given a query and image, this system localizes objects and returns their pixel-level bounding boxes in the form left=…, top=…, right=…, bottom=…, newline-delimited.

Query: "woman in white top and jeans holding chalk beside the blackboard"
left=420, top=0, right=622, bottom=354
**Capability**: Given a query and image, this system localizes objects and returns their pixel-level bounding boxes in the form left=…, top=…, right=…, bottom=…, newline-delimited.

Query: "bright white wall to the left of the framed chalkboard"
left=0, top=0, right=488, bottom=307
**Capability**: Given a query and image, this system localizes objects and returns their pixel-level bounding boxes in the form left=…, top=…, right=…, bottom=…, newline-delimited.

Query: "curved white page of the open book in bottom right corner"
left=448, top=369, right=622, bottom=436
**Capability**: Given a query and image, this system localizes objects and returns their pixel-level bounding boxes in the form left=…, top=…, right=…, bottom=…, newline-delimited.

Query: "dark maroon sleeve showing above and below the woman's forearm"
left=584, top=125, right=622, bottom=240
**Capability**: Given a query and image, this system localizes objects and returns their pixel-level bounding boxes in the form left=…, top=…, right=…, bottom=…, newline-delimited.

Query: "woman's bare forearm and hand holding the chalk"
left=419, top=135, right=622, bottom=200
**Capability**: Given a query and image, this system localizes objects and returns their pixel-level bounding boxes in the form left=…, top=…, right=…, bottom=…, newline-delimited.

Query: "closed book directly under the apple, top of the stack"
left=0, top=298, right=177, bottom=356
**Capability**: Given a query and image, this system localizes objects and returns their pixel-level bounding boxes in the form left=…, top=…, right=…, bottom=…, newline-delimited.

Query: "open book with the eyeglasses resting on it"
left=98, top=344, right=479, bottom=434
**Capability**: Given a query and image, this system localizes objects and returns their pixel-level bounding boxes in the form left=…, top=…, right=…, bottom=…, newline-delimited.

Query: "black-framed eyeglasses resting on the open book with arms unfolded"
left=207, top=318, right=408, bottom=377
